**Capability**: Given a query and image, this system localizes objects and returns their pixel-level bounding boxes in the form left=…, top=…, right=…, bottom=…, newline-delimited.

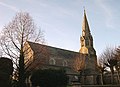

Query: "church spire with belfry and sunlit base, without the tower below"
left=80, top=9, right=94, bottom=54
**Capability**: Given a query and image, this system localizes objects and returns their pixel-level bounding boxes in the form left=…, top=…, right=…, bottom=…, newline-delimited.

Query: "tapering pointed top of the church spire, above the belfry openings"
left=82, top=9, right=90, bottom=33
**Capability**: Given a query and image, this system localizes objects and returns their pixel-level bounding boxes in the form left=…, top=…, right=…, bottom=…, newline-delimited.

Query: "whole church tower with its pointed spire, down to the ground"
left=79, top=10, right=97, bottom=84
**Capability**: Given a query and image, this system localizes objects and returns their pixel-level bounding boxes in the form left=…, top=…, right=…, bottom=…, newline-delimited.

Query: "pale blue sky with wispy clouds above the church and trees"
left=0, top=0, right=120, bottom=56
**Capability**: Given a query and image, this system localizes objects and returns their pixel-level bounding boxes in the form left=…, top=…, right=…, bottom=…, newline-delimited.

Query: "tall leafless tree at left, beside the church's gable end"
left=0, top=12, right=44, bottom=87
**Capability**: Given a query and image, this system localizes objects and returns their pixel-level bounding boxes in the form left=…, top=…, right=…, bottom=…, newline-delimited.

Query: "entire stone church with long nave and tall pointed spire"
left=24, top=10, right=98, bottom=84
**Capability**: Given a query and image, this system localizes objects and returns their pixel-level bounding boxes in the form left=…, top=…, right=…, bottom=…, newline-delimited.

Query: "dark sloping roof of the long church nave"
left=28, top=41, right=79, bottom=58
